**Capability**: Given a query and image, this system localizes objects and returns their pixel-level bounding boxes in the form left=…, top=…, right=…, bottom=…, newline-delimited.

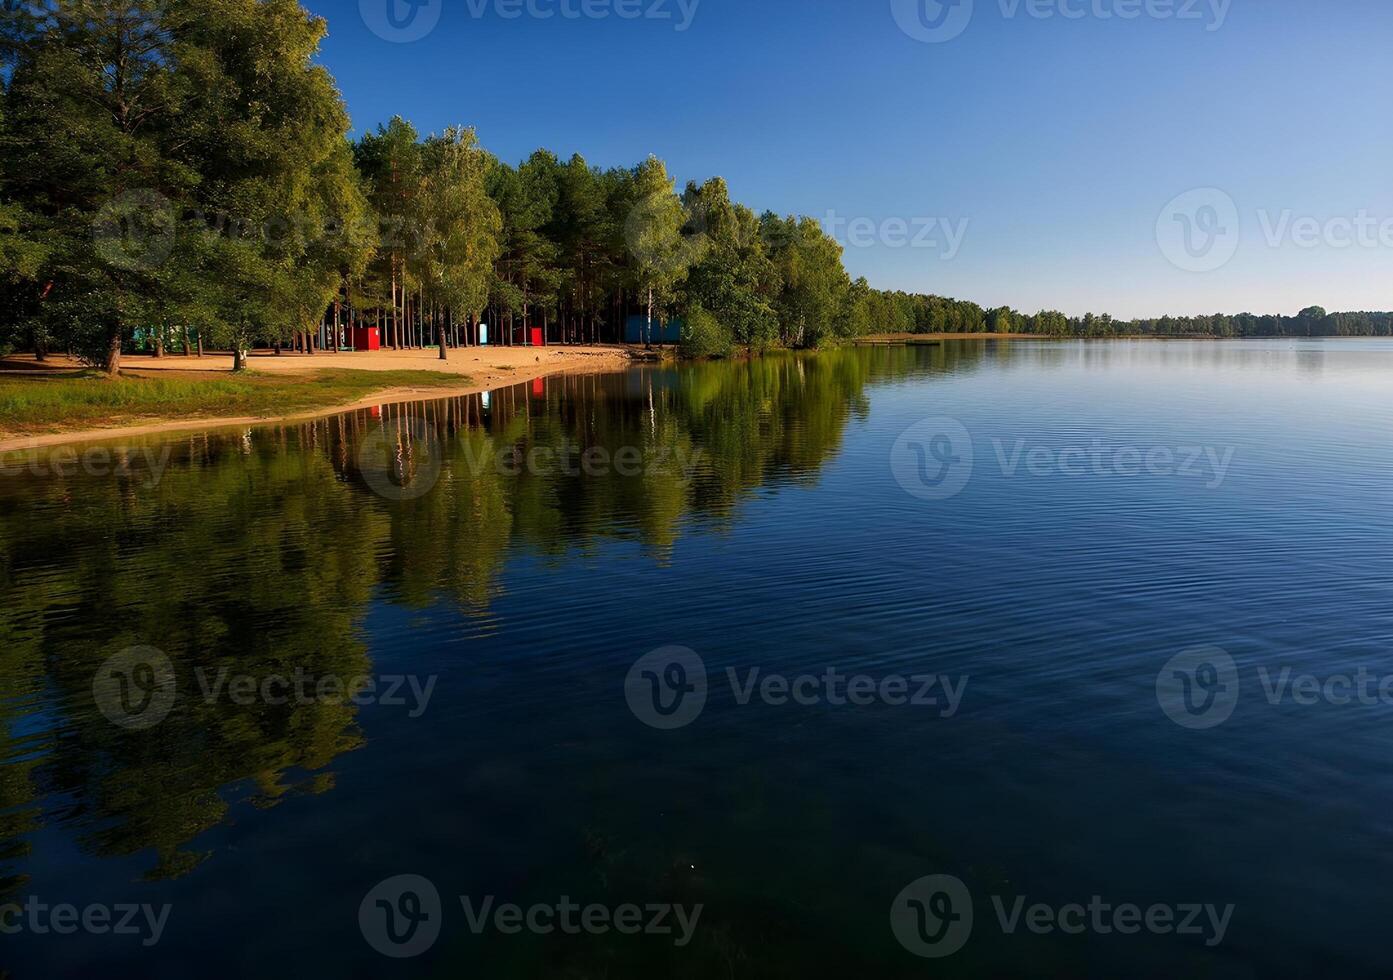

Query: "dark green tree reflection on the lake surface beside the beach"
left=0, top=344, right=983, bottom=891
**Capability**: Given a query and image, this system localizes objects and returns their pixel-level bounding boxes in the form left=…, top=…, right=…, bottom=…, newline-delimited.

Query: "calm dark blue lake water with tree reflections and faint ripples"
left=0, top=341, right=1393, bottom=979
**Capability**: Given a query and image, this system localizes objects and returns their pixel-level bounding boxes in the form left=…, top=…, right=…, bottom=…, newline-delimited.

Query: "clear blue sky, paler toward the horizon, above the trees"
left=305, top=0, right=1393, bottom=316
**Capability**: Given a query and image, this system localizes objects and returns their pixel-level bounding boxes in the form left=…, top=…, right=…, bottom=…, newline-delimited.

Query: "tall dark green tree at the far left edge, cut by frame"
left=0, top=0, right=195, bottom=374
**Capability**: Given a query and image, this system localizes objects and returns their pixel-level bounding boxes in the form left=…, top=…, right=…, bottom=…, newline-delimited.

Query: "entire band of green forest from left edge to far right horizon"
left=0, top=0, right=1393, bottom=374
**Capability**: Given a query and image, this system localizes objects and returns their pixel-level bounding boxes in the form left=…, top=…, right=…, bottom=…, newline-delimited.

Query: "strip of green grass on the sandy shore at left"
left=0, top=369, right=469, bottom=436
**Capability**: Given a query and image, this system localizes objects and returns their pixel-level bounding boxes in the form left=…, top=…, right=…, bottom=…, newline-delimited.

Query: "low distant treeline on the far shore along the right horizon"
left=864, top=292, right=1393, bottom=337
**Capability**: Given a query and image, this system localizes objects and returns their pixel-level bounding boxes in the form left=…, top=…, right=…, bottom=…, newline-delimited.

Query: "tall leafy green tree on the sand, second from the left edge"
left=171, top=0, right=362, bottom=370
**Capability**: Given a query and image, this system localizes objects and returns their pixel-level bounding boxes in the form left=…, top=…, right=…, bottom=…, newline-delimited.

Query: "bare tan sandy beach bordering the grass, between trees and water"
left=0, top=347, right=637, bottom=455
